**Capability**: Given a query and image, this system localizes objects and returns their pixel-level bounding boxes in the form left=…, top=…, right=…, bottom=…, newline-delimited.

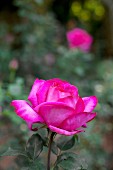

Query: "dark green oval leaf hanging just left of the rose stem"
left=26, top=134, right=43, bottom=160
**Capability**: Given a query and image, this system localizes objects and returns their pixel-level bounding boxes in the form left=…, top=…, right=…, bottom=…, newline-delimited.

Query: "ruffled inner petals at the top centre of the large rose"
left=37, top=78, right=78, bottom=104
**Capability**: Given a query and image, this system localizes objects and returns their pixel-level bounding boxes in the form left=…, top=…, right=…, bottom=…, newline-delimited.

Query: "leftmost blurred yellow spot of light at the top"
left=71, top=2, right=82, bottom=15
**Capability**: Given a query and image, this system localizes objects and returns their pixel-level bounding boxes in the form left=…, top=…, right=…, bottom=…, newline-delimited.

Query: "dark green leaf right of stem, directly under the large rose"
left=57, top=136, right=75, bottom=151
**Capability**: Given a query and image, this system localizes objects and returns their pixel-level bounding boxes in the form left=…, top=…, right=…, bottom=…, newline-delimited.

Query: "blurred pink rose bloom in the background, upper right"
left=67, top=28, right=93, bottom=52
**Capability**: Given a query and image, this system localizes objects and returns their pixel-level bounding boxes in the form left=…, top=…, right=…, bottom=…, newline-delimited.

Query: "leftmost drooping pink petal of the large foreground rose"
left=11, top=100, right=44, bottom=130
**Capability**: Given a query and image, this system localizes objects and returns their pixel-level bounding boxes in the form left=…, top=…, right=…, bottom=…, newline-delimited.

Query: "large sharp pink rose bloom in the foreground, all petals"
left=11, top=78, right=98, bottom=135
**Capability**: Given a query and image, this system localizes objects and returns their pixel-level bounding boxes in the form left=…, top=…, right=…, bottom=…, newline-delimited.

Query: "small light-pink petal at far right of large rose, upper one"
left=82, top=96, right=98, bottom=112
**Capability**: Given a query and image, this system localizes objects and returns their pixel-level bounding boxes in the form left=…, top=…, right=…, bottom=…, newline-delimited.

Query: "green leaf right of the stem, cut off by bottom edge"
left=54, top=152, right=87, bottom=170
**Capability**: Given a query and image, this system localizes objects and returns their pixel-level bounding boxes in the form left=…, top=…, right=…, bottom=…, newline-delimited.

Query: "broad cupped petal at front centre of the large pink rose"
left=34, top=102, right=75, bottom=127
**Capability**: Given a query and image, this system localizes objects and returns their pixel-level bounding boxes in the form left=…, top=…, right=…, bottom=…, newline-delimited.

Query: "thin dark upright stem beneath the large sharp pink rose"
left=47, top=132, right=55, bottom=170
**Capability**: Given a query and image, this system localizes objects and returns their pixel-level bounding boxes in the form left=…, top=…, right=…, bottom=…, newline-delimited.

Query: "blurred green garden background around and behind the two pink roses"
left=0, top=0, right=113, bottom=170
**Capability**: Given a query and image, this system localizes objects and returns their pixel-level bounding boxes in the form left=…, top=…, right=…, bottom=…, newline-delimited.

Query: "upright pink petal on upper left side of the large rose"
left=28, top=79, right=45, bottom=107
